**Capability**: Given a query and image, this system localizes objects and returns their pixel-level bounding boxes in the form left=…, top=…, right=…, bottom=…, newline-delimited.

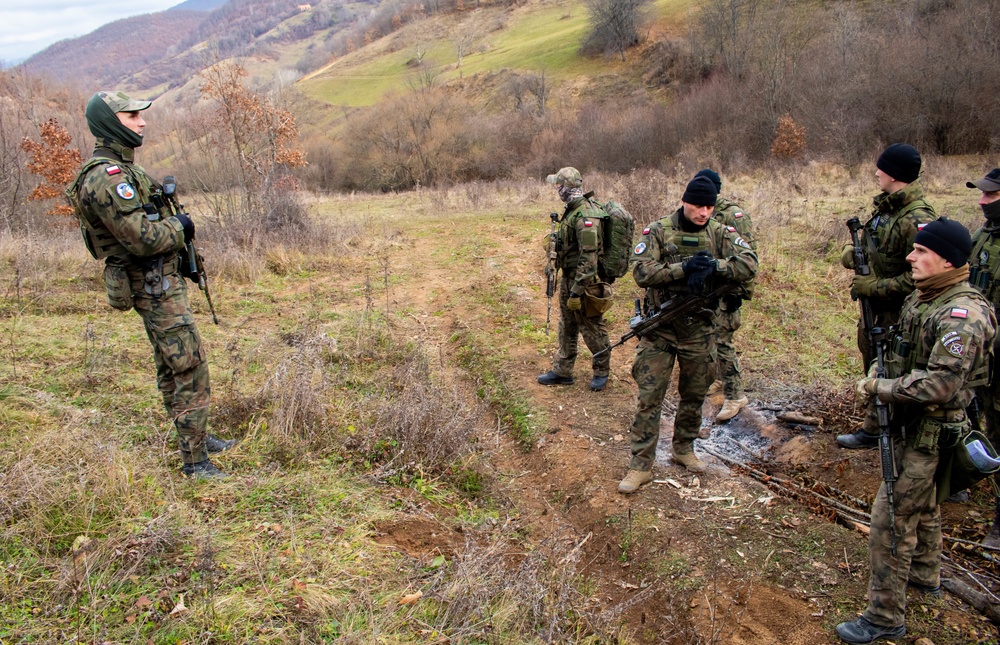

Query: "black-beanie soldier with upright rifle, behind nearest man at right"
left=837, top=143, right=937, bottom=448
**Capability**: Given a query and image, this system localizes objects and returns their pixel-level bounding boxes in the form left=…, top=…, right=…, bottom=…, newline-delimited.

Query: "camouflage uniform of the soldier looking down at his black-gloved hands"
left=629, top=208, right=757, bottom=471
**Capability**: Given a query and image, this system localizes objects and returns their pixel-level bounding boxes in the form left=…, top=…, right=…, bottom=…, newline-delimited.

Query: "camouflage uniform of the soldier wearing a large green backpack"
left=552, top=197, right=611, bottom=377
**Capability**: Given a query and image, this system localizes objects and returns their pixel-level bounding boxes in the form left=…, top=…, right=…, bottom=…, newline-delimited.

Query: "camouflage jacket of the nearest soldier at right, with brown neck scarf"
left=877, top=281, right=997, bottom=416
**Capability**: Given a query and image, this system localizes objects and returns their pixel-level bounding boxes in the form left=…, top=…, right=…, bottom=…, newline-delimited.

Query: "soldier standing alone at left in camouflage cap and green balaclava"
left=66, top=92, right=235, bottom=477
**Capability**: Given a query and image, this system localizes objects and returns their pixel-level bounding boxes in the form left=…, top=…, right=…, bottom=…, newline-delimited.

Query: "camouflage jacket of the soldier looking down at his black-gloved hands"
left=631, top=209, right=757, bottom=306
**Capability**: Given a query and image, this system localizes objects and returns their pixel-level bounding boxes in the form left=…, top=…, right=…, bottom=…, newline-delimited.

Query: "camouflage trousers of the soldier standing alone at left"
left=130, top=264, right=211, bottom=464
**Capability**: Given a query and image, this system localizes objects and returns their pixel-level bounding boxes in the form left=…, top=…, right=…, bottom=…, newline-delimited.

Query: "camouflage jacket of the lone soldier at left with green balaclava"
left=66, top=140, right=184, bottom=265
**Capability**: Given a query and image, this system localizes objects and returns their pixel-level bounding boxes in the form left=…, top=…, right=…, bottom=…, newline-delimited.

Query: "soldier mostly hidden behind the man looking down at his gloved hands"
left=695, top=168, right=757, bottom=421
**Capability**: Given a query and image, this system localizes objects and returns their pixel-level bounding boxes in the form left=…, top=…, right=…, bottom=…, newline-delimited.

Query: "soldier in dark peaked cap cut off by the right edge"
left=965, top=168, right=1000, bottom=547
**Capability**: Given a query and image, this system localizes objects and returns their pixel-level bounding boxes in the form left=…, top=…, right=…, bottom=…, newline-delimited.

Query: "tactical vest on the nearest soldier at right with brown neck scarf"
left=886, top=283, right=991, bottom=394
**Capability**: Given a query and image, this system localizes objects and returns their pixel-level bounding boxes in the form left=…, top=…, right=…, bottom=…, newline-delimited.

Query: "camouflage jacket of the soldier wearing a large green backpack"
left=556, top=197, right=607, bottom=294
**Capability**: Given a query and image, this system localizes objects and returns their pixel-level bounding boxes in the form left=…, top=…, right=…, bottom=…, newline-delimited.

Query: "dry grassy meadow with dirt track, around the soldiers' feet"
left=0, top=157, right=1000, bottom=645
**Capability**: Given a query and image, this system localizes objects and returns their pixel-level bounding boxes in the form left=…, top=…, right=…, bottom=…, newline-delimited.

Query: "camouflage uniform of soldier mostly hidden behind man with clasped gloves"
left=712, top=197, right=757, bottom=399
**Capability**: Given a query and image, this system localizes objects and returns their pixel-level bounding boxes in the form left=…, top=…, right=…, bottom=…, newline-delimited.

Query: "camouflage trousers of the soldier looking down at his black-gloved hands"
left=629, top=318, right=716, bottom=470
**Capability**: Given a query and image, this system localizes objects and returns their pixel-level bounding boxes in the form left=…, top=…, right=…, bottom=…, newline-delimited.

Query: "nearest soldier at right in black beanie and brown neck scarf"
left=837, top=218, right=996, bottom=643
